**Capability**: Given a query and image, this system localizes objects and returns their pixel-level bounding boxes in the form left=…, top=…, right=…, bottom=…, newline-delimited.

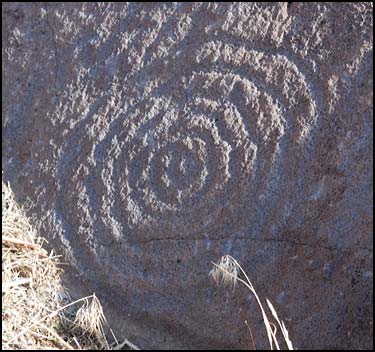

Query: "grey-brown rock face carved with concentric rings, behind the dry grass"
left=2, top=3, right=373, bottom=349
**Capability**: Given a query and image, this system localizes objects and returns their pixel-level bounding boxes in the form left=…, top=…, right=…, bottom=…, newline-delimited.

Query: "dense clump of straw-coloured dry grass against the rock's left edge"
left=2, top=183, right=138, bottom=350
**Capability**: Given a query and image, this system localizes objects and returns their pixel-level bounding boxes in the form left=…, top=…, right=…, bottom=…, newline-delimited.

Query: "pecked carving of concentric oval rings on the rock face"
left=56, top=31, right=317, bottom=296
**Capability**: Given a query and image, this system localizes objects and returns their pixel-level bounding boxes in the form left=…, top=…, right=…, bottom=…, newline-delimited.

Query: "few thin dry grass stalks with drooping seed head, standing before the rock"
left=210, top=255, right=293, bottom=350
